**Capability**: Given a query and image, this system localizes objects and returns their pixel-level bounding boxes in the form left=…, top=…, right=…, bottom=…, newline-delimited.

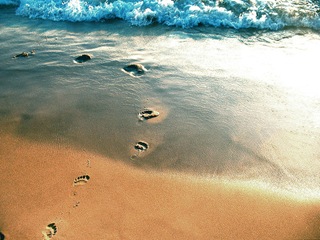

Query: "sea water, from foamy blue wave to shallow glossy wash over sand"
left=0, top=0, right=320, bottom=197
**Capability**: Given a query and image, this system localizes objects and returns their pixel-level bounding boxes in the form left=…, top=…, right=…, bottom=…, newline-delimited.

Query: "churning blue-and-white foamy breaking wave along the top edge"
left=14, top=0, right=320, bottom=30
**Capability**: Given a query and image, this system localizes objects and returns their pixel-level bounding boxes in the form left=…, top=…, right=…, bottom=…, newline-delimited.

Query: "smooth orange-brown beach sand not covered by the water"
left=0, top=134, right=320, bottom=240
